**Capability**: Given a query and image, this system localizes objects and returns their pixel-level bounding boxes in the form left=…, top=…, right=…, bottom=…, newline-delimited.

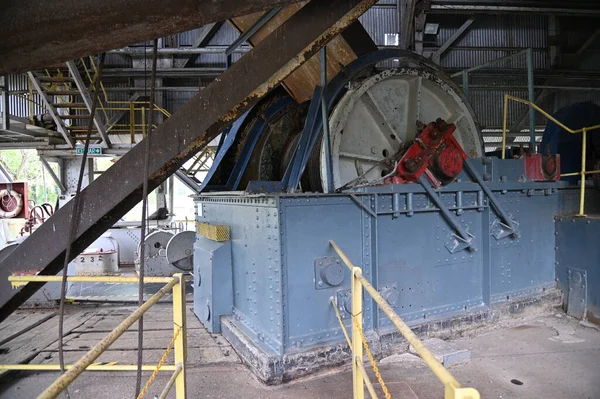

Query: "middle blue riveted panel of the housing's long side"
left=377, top=211, right=483, bottom=329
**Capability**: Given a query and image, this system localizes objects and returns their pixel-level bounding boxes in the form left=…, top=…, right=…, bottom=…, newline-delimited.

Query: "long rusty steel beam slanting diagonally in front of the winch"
left=0, top=0, right=376, bottom=321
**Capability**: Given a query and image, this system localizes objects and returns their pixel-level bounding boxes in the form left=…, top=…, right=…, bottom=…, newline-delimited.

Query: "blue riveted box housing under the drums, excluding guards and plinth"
left=194, top=159, right=578, bottom=356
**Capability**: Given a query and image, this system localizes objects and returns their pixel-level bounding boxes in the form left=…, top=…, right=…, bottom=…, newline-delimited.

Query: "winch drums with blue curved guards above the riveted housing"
left=203, top=50, right=483, bottom=192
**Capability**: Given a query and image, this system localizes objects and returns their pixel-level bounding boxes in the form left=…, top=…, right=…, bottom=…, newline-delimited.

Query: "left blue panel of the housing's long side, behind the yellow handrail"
left=281, top=196, right=371, bottom=350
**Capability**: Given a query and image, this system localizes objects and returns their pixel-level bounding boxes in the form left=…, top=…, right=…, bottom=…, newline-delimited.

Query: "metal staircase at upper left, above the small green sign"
left=27, top=61, right=110, bottom=148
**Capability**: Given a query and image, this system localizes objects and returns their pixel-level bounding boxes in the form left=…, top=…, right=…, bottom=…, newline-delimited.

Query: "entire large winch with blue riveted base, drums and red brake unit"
left=193, top=50, right=578, bottom=383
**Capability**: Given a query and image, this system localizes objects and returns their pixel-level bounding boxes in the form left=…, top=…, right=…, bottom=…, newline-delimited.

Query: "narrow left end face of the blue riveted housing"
left=196, top=196, right=283, bottom=352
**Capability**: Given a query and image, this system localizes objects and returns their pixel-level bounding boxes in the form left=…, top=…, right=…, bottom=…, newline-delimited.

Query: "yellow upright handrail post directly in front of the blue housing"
left=351, top=266, right=365, bottom=399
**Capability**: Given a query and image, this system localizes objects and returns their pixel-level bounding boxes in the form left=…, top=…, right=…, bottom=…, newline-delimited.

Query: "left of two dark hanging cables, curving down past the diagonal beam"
left=58, top=53, right=106, bottom=398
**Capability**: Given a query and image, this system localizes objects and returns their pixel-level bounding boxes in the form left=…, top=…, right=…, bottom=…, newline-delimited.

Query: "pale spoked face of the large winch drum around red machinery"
left=320, top=67, right=483, bottom=191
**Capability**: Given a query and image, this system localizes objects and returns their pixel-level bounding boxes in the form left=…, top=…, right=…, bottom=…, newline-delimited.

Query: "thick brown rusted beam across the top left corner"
left=0, top=0, right=308, bottom=75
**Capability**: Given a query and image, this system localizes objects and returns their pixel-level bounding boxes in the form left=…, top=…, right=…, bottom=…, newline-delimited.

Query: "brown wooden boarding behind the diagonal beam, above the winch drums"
left=229, top=1, right=356, bottom=103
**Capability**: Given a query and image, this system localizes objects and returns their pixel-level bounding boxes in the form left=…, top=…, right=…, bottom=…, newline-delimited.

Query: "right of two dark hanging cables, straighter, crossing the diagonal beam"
left=135, top=39, right=158, bottom=398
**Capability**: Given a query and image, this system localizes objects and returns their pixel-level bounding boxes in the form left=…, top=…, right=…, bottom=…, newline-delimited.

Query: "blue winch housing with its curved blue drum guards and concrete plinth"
left=194, top=50, right=590, bottom=383
